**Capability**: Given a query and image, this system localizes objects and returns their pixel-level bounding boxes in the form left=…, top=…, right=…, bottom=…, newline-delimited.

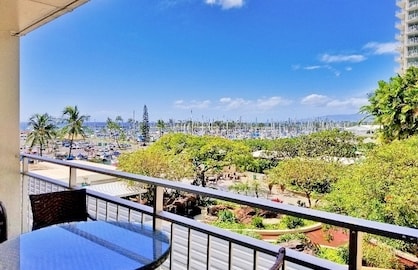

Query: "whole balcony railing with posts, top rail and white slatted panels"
left=21, top=154, right=418, bottom=270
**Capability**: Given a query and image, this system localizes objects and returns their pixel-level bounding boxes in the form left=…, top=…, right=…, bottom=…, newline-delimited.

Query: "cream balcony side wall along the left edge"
left=0, top=29, right=22, bottom=238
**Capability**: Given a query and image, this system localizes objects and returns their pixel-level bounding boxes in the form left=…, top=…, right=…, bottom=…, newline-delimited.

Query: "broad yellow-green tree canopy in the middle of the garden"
left=119, top=133, right=252, bottom=186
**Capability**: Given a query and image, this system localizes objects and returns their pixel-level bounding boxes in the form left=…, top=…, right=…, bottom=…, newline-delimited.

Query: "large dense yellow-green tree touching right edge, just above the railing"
left=326, top=136, right=418, bottom=228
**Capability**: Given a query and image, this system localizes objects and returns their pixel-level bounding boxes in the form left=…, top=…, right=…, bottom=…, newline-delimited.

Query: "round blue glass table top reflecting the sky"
left=0, top=221, right=170, bottom=270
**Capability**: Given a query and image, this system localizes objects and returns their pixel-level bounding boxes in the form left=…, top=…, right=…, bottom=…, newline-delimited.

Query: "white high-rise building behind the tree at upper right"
left=396, top=0, right=418, bottom=73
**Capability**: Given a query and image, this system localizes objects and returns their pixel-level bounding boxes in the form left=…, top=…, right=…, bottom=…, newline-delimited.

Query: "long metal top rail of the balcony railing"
left=21, top=154, right=418, bottom=243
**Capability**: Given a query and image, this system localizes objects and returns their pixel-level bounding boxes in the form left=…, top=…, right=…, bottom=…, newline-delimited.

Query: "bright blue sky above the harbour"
left=20, top=0, right=399, bottom=122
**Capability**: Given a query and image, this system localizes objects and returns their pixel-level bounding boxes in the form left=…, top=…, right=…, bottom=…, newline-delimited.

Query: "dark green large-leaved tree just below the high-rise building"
left=360, top=67, right=418, bottom=141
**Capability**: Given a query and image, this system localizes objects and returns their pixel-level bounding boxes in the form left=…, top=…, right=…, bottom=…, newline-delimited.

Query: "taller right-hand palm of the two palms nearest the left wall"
left=62, top=106, right=89, bottom=157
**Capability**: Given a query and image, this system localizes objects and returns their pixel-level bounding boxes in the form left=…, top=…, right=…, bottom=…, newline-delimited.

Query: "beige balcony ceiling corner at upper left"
left=0, top=0, right=89, bottom=36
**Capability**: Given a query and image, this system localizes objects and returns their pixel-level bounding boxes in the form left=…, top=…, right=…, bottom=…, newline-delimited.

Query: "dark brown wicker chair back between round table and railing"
left=29, top=189, right=88, bottom=230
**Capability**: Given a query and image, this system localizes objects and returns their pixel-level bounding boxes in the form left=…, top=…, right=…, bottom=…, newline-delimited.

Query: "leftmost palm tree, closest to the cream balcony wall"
left=26, top=113, right=56, bottom=156
